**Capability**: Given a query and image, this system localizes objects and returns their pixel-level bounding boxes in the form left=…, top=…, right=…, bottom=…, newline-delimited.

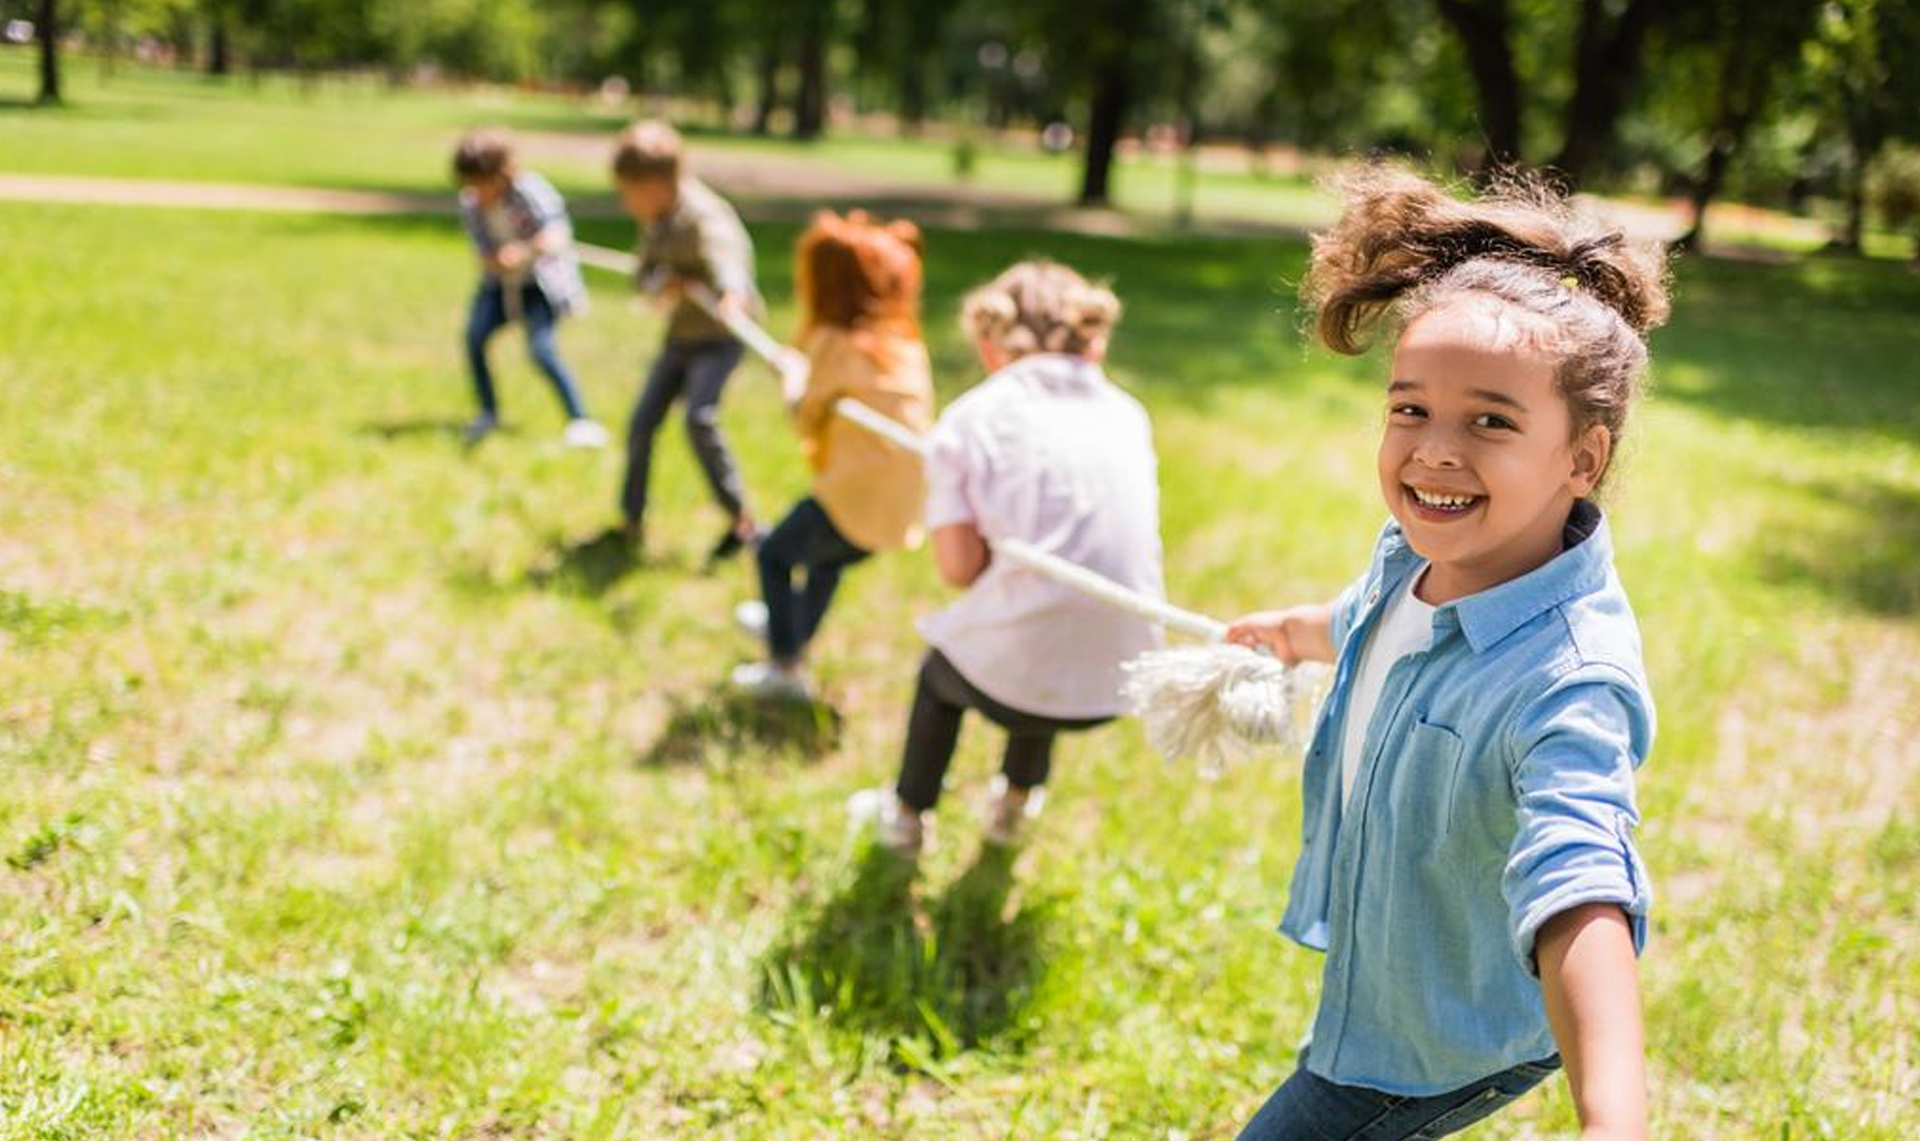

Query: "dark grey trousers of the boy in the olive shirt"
left=620, top=330, right=747, bottom=524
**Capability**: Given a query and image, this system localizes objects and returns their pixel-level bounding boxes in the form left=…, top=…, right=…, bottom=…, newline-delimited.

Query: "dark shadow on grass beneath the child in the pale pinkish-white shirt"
left=758, top=845, right=1050, bottom=1070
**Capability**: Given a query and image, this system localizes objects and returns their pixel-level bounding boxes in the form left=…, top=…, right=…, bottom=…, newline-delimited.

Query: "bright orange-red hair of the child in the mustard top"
left=793, top=209, right=925, bottom=336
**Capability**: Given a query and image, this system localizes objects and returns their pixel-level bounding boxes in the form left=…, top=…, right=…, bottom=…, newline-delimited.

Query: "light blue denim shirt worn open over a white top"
left=1281, top=501, right=1653, bottom=1095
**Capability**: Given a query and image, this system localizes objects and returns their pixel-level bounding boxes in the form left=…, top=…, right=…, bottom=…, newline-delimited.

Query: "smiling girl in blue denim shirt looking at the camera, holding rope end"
left=1229, top=169, right=1667, bottom=1141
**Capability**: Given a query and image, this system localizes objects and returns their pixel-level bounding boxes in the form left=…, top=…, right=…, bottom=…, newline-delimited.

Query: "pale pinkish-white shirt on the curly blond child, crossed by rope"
left=920, top=353, right=1165, bottom=720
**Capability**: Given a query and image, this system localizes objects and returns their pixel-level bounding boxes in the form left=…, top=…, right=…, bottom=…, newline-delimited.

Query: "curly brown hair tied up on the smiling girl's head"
left=1302, top=165, right=1667, bottom=478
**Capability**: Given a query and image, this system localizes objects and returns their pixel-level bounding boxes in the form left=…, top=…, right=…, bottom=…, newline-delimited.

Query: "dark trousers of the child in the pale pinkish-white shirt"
left=895, top=649, right=1114, bottom=813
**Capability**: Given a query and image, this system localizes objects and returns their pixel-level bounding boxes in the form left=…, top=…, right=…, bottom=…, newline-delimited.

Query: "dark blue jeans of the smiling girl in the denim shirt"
left=1240, top=1055, right=1559, bottom=1141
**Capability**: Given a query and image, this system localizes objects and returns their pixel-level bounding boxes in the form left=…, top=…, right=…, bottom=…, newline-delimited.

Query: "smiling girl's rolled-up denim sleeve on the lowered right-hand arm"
left=1501, top=670, right=1653, bottom=974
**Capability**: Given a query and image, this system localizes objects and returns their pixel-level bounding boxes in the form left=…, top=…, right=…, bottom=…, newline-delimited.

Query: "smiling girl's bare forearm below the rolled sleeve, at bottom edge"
left=1534, top=903, right=1647, bottom=1141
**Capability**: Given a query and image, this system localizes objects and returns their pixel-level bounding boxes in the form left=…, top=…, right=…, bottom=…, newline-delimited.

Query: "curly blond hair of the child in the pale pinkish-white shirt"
left=960, top=259, right=1119, bottom=357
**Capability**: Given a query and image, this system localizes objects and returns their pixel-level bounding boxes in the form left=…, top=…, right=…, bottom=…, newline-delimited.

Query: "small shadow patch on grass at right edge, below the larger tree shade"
left=1757, top=474, right=1920, bottom=619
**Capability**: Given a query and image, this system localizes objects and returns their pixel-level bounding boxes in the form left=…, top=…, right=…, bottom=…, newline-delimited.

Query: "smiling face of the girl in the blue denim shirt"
left=1380, top=296, right=1611, bottom=605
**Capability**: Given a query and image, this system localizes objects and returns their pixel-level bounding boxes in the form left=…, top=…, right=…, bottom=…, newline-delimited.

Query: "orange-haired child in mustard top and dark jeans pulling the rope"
left=733, top=211, right=933, bottom=697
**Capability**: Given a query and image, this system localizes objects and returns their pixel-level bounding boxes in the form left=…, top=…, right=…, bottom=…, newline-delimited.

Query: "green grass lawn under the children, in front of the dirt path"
left=0, top=57, right=1920, bottom=1141
